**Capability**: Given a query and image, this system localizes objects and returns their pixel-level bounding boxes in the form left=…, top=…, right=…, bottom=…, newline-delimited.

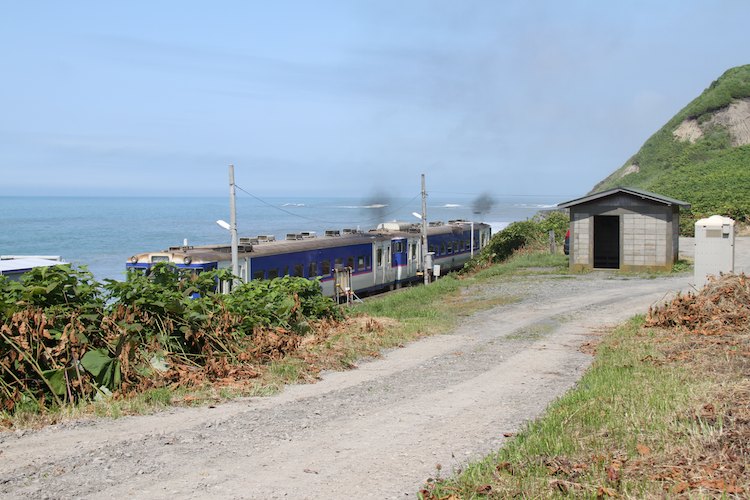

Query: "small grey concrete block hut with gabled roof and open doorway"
left=558, top=188, right=690, bottom=271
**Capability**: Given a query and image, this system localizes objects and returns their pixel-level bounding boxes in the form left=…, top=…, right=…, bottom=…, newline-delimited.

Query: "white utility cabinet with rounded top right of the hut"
left=695, top=215, right=734, bottom=288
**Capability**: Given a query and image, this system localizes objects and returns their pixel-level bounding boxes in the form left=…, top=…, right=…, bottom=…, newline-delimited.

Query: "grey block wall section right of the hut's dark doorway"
left=621, top=213, right=672, bottom=267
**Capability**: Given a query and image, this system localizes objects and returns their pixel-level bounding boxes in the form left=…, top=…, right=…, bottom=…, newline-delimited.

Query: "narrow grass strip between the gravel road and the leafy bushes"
left=0, top=251, right=567, bottom=428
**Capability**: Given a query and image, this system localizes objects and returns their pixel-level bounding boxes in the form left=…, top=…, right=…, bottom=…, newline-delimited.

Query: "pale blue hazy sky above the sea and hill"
left=0, top=0, right=750, bottom=201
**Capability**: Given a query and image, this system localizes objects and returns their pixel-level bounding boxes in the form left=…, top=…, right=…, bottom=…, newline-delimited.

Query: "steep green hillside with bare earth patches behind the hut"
left=592, top=65, right=750, bottom=231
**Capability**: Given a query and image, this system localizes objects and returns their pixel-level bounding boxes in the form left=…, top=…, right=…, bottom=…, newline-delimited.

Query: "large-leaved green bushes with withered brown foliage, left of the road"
left=0, top=264, right=341, bottom=418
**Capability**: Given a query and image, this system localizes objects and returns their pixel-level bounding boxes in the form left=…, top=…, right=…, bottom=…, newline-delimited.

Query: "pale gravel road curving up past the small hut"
left=0, top=238, right=750, bottom=499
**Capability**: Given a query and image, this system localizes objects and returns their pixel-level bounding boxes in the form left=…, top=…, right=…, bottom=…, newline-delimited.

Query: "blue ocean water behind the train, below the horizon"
left=0, top=192, right=558, bottom=281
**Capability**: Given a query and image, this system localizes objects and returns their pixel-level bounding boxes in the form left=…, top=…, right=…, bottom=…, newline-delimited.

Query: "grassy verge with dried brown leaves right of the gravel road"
left=420, top=317, right=750, bottom=500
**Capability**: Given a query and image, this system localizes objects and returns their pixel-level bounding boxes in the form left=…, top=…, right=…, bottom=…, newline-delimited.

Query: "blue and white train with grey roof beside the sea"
left=126, top=221, right=490, bottom=297
